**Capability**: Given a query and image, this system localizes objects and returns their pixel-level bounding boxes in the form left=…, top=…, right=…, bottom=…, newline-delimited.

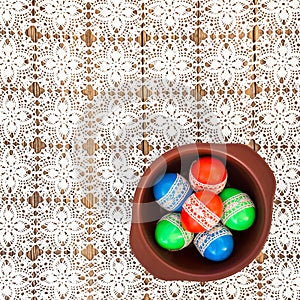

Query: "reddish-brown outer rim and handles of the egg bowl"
left=130, top=143, right=276, bottom=281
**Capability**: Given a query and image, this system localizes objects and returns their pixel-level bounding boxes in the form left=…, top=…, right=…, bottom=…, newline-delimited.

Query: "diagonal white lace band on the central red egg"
left=183, top=194, right=220, bottom=230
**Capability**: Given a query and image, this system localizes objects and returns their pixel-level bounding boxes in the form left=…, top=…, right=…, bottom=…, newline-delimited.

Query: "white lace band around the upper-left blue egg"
left=157, top=174, right=190, bottom=211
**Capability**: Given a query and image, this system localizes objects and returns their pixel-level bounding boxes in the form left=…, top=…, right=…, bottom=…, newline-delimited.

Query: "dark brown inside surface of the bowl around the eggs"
left=139, top=149, right=266, bottom=279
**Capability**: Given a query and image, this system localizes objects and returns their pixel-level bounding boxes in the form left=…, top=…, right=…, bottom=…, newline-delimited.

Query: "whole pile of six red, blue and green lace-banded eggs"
left=153, top=156, right=255, bottom=261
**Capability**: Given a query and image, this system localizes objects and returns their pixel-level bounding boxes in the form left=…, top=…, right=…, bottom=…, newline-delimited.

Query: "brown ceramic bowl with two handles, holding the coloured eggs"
left=130, top=143, right=275, bottom=281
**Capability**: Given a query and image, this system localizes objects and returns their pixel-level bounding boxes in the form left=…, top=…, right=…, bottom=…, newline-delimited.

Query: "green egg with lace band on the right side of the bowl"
left=220, top=188, right=255, bottom=231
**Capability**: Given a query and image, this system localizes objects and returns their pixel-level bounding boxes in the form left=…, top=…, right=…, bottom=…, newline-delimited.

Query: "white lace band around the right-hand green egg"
left=221, top=193, right=254, bottom=224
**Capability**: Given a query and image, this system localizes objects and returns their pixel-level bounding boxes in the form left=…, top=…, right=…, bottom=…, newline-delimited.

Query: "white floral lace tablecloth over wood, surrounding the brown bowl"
left=0, top=0, right=300, bottom=300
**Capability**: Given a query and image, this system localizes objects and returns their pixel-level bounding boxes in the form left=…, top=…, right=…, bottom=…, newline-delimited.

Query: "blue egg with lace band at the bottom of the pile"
left=194, top=224, right=234, bottom=261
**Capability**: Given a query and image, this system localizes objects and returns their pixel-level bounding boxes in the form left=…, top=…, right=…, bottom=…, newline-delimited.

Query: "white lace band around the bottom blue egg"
left=194, top=224, right=232, bottom=255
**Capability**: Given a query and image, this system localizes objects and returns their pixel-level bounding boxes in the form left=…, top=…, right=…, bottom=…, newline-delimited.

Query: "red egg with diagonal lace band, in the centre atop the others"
left=181, top=190, right=223, bottom=233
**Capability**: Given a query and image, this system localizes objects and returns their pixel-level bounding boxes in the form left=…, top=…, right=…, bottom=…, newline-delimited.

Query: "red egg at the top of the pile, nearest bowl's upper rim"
left=189, top=156, right=227, bottom=194
